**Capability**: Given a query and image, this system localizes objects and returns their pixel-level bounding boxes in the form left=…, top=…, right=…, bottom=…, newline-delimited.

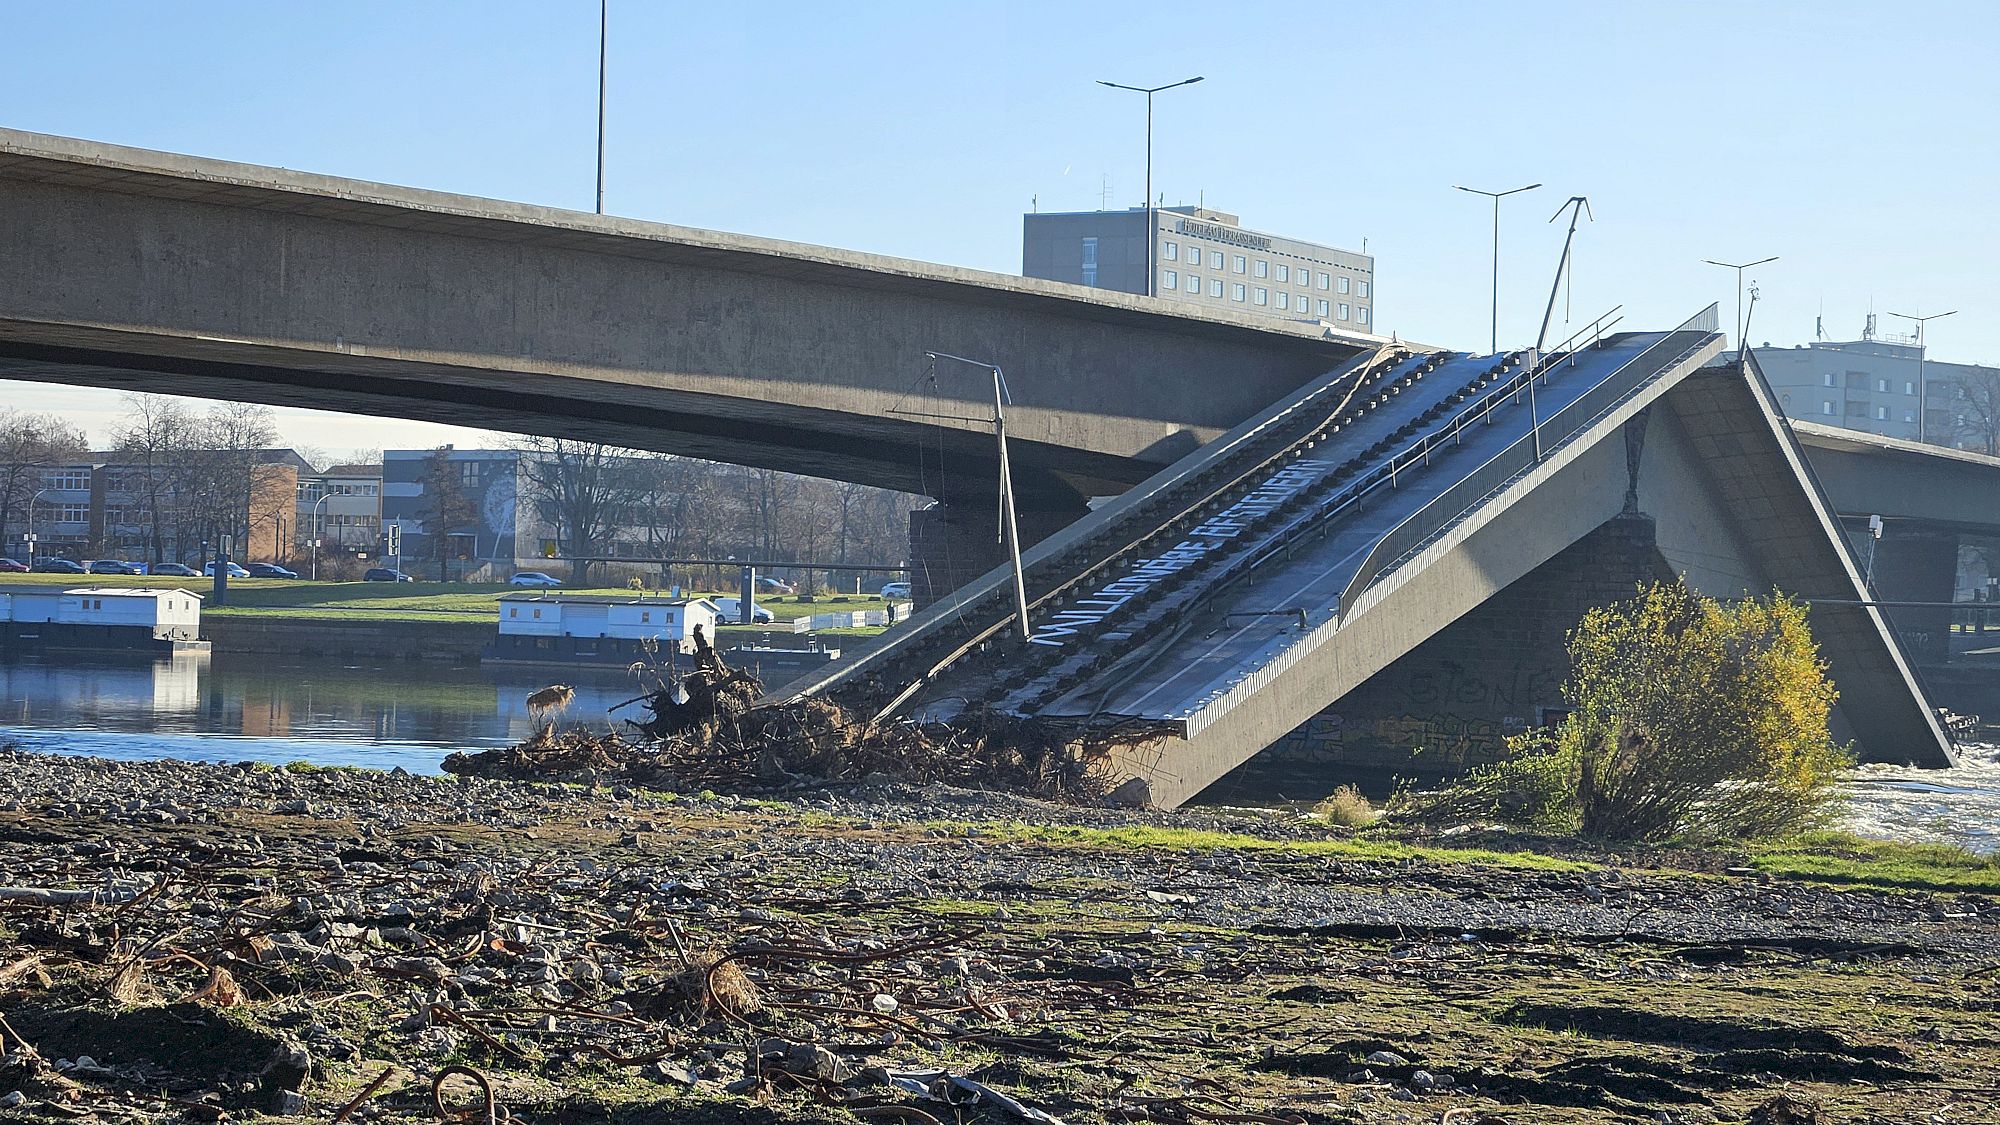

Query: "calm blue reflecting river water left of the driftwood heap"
left=0, top=655, right=636, bottom=773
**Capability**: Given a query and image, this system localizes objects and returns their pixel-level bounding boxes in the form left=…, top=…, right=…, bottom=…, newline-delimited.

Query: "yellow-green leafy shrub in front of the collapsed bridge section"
left=1418, top=581, right=1852, bottom=841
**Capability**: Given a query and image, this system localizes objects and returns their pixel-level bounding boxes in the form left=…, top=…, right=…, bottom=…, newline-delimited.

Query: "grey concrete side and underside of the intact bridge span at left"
left=0, top=130, right=1372, bottom=506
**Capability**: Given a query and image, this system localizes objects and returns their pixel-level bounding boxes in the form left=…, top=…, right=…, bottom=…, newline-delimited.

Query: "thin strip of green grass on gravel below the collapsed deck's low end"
left=930, top=821, right=1598, bottom=871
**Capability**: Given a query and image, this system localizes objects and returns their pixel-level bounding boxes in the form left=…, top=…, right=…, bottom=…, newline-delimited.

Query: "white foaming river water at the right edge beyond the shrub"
left=1846, top=743, right=2000, bottom=853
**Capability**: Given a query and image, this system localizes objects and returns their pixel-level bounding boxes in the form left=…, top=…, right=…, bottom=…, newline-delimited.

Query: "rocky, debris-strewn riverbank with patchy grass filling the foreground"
left=0, top=751, right=2000, bottom=1125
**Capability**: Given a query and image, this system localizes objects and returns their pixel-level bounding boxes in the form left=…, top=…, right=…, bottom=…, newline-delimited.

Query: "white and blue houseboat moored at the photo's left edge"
left=0, top=585, right=208, bottom=657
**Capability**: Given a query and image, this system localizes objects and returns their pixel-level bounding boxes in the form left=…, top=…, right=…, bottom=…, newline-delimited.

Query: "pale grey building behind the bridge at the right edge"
left=1752, top=338, right=2000, bottom=452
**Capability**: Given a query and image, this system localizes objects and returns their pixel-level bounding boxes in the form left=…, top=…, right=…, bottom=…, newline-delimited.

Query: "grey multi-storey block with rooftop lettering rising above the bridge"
left=1020, top=206, right=1376, bottom=332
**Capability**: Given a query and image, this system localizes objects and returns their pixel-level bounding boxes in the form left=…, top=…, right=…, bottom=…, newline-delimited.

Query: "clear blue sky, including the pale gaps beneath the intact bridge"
left=0, top=0, right=2000, bottom=450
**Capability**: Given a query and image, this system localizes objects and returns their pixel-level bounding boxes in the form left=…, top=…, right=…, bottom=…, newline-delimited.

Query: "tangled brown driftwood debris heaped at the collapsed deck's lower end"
left=444, top=649, right=1156, bottom=805
